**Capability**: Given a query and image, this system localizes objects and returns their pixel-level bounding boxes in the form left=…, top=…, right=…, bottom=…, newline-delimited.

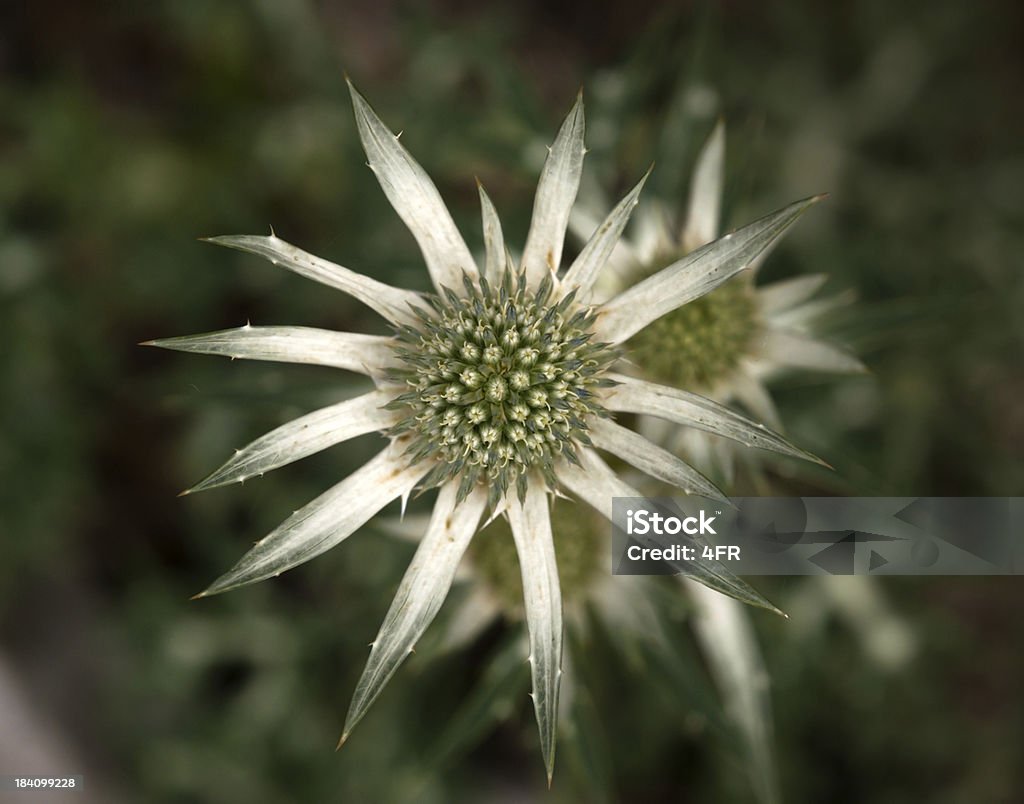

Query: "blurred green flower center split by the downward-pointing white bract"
left=469, top=500, right=607, bottom=616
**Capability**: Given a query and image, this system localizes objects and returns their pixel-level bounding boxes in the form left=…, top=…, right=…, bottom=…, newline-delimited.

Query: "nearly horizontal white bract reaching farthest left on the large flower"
left=142, top=325, right=397, bottom=377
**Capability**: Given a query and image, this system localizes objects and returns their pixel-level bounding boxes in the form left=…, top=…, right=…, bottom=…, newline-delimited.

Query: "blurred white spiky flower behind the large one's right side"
left=570, top=122, right=866, bottom=477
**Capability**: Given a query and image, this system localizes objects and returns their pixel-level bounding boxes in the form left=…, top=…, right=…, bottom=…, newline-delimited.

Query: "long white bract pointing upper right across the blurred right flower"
left=595, top=197, right=819, bottom=343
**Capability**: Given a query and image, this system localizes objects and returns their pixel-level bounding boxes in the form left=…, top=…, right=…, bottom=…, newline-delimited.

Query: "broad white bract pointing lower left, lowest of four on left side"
left=200, top=441, right=429, bottom=597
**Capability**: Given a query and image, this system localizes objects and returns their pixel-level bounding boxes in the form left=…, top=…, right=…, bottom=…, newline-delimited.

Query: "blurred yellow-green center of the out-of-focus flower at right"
left=628, top=266, right=760, bottom=390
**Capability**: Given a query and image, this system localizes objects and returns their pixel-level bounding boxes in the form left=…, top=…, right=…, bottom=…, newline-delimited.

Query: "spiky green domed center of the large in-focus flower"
left=389, top=269, right=615, bottom=506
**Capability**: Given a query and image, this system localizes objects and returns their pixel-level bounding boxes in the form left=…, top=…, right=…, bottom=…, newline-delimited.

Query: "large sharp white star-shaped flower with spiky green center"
left=147, top=79, right=817, bottom=785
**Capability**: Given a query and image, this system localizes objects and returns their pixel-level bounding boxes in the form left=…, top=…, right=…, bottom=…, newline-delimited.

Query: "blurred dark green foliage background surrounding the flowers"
left=0, top=1, right=1024, bottom=802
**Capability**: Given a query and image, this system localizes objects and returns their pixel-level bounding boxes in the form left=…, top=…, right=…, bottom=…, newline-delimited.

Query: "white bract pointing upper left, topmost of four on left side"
left=205, top=235, right=423, bottom=324
